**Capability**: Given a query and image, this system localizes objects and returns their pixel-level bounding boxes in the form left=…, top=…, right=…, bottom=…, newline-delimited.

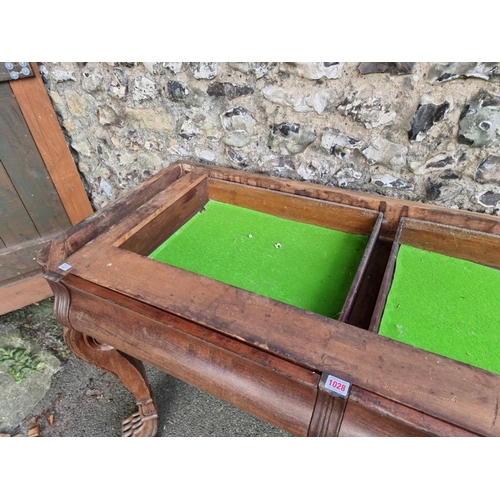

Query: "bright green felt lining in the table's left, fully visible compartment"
left=150, top=200, right=368, bottom=318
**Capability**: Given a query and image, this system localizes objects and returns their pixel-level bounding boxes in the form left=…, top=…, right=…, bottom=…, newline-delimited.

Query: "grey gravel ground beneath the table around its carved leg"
left=0, top=299, right=288, bottom=437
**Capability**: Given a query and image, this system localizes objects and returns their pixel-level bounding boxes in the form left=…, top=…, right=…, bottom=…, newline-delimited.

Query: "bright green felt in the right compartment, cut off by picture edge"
left=379, top=245, right=500, bottom=373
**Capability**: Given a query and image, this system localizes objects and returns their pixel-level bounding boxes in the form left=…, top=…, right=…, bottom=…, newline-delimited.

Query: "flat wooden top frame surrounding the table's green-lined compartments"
left=39, top=162, right=500, bottom=435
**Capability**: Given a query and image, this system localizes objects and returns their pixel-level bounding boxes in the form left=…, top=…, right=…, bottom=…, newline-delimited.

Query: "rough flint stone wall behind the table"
left=39, top=62, right=500, bottom=214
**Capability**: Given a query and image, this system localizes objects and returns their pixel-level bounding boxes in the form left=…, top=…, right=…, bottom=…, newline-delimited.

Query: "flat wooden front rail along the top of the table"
left=61, top=243, right=500, bottom=435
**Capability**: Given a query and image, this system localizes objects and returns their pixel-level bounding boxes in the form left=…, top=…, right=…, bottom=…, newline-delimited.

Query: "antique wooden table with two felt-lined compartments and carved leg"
left=38, top=162, right=500, bottom=436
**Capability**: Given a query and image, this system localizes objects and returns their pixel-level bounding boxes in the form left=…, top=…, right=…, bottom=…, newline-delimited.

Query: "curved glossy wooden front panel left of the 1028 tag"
left=70, top=289, right=316, bottom=435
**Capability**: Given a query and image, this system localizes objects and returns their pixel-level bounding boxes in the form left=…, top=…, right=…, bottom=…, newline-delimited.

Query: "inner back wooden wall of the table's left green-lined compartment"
left=209, top=179, right=377, bottom=235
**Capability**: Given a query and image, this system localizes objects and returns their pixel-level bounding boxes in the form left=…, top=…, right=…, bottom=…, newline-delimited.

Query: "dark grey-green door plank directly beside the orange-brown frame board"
left=0, top=79, right=71, bottom=236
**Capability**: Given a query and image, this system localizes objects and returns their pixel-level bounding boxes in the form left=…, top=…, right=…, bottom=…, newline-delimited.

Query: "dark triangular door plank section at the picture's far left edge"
left=0, top=161, right=40, bottom=246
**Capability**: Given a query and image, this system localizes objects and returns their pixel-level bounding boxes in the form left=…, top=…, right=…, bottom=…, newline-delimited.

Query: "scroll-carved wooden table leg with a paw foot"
left=64, top=328, right=158, bottom=437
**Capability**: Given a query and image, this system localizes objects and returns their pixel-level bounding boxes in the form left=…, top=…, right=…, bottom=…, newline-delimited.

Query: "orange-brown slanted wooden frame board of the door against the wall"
left=10, top=64, right=93, bottom=224
